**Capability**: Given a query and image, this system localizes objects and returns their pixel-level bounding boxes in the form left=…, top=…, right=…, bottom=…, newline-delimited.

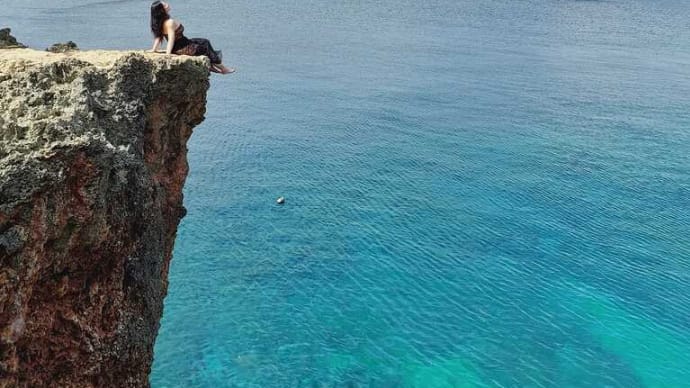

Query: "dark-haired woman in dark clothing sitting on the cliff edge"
left=151, top=1, right=235, bottom=74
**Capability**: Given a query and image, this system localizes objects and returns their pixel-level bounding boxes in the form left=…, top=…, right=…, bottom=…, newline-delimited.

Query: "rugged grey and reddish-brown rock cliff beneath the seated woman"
left=0, top=49, right=209, bottom=387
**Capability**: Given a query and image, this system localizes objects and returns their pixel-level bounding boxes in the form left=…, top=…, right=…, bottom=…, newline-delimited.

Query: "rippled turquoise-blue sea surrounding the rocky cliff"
left=0, top=0, right=690, bottom=387
